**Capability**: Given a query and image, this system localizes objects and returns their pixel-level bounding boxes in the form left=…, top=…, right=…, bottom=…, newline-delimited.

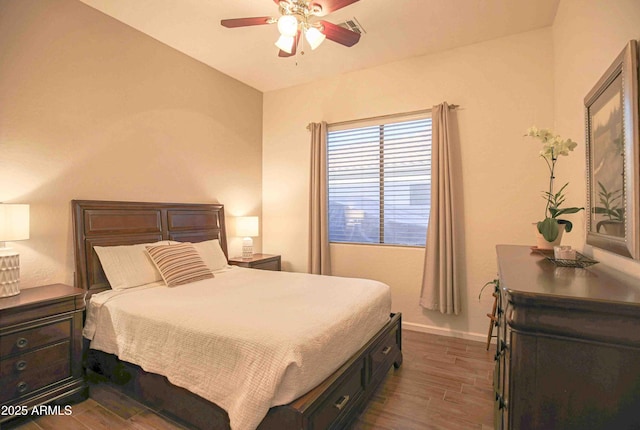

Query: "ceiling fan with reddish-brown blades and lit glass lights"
left=220, top=0, right=360, bottom=57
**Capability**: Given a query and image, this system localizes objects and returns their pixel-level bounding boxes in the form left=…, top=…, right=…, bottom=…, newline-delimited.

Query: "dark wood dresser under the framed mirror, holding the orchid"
left=494, top=245, right=640, bottom=430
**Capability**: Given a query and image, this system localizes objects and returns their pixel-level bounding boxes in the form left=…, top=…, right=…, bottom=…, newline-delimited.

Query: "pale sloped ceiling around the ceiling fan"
left=81, top=0, right=559, bottom=92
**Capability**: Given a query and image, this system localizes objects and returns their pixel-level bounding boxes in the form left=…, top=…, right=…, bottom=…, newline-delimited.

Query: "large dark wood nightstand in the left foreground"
left=0, top=284, right=89, bottom=423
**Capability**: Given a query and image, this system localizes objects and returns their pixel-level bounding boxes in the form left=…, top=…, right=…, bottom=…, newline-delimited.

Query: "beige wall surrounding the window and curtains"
left=263, top=28, right=556, bottom=337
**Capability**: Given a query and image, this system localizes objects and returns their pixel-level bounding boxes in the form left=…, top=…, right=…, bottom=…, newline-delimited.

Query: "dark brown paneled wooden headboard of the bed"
left=71, top=200, right=228, bottom=294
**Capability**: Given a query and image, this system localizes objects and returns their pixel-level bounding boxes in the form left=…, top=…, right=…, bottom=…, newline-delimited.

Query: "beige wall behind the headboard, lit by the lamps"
left=0, top=0, right=262, bottom=287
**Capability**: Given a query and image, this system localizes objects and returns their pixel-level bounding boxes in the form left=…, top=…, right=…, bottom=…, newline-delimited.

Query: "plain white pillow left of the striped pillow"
left=93, top=240, right=167, bottom=290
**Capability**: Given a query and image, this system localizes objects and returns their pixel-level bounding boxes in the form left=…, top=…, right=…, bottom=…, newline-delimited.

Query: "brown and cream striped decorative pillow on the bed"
left=147, top=243, right=213, bottom=287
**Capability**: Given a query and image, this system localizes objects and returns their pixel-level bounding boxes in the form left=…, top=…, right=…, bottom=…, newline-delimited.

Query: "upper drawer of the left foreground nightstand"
left=0, top=319, right=71, bottom=359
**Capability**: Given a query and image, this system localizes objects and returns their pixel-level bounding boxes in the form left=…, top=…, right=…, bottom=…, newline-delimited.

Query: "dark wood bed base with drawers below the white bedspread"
left=86, top=313, right=402, bottom=430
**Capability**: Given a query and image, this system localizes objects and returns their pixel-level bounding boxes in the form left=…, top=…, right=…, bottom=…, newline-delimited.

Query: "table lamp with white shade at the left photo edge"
left=0, top=203, right=29, bottom=298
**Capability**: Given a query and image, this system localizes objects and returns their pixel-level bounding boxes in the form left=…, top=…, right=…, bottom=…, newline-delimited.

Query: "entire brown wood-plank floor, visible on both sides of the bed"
left=2, top=330, right=493, bottom=430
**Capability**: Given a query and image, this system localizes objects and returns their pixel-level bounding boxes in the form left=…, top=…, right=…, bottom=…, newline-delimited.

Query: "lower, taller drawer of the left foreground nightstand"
left=0, top=341, right=71, bottom=403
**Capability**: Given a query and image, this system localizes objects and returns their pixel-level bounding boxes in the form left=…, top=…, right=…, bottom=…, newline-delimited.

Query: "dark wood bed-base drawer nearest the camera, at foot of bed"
left=310, top=361, right=364, bottom=430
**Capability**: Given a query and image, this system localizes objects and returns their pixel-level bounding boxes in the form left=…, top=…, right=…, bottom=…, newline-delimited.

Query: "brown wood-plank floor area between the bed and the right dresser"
left=351, top=330, right=495, bottom=430
